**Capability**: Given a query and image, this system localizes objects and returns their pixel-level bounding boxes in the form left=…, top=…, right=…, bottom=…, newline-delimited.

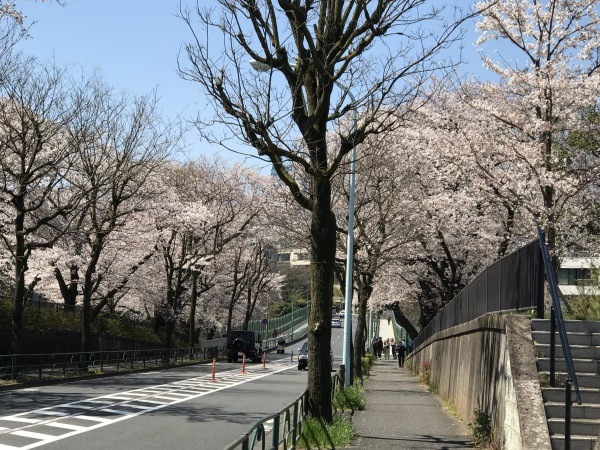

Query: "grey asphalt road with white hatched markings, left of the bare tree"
left=0, top=320, right=350, bottom=450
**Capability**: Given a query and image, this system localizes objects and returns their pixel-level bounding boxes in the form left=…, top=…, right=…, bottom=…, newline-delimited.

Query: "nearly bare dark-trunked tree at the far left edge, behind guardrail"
left=0, top=59, right=86, bottom=352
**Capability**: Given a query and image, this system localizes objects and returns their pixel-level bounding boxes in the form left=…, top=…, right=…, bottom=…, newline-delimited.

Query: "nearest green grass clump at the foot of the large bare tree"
left=296, top=416, right=355, bottom=449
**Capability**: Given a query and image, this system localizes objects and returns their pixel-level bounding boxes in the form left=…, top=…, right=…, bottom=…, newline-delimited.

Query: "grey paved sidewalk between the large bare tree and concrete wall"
left=350, top=359, right=474, bottom=450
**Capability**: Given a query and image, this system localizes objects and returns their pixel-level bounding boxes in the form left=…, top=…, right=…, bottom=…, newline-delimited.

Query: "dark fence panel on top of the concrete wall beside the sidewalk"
left=414, top=239, right=544, bottom=347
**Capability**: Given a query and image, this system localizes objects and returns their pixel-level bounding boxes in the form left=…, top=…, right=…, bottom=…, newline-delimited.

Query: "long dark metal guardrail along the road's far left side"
left=0, top=347, right=224, bottom=380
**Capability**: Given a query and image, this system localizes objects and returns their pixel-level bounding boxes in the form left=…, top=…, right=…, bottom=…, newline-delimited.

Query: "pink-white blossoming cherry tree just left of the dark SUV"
left=146, top=160, right=262, bottom=345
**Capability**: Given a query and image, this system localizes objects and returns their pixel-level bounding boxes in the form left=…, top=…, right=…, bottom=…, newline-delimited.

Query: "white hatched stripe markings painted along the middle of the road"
left=0, top=363, right=292, bottom=450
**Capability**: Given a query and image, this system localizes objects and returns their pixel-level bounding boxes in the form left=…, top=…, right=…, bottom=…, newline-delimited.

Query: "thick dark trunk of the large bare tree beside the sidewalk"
left=308, top=177, right=336, bottom=422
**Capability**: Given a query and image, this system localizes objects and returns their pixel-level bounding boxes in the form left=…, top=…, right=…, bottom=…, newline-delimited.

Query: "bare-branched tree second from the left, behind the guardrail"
left=64, top=80, right=178, bottom=351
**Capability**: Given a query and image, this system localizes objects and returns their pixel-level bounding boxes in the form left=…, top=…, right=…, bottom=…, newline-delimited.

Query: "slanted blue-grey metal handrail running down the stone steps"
left=537, top=225, right=581, bottom=405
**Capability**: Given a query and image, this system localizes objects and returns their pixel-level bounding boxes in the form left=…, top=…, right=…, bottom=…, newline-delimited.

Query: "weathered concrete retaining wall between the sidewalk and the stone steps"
left=406, top=315, right=551, bottom=450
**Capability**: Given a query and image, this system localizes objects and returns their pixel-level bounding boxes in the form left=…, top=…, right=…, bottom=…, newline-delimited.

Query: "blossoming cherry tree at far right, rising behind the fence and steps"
left=472, top=0, right=600, bottom=269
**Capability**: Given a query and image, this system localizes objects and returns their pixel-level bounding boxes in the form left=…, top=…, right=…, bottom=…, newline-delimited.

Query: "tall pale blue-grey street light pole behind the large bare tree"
left=250, top=59, right=357, bottom=386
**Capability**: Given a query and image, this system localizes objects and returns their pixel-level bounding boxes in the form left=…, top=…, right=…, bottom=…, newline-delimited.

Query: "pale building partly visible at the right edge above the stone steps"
left=556, top=257, right=600, bottom=297
